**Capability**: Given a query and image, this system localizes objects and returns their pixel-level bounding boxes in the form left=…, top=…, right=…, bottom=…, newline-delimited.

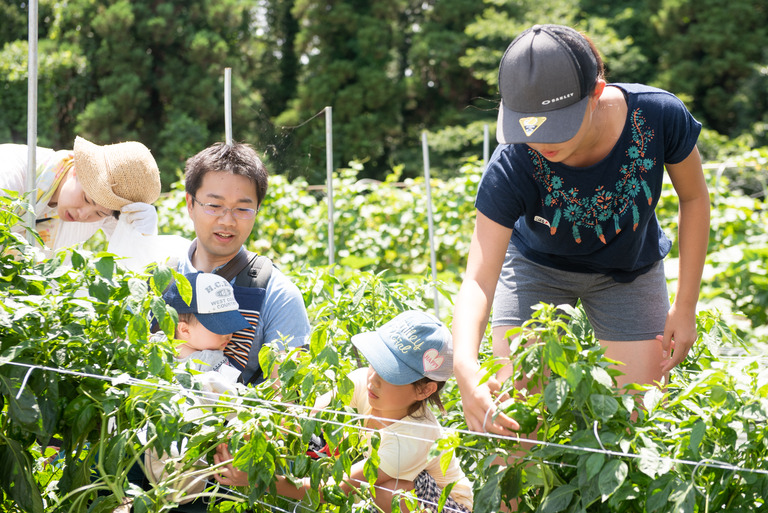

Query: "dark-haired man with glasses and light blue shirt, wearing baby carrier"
left=178, top=143, right=310, bottom=383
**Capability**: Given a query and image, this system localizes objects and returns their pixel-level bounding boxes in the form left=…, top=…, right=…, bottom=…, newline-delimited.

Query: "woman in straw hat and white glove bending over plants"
left=0, top=137, right=160, bottom=250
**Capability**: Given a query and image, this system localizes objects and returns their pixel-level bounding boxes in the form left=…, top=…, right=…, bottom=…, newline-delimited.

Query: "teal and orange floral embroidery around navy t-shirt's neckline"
left=528, top=109, right=656, bottom=244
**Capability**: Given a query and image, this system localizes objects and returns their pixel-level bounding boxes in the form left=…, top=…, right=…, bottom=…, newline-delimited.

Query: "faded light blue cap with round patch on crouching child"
left=352, top=310, right=453, bottom=385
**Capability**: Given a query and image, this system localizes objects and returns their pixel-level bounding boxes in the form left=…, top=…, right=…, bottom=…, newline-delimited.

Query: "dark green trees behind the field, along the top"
left=0, top=0, right=768, bottom=188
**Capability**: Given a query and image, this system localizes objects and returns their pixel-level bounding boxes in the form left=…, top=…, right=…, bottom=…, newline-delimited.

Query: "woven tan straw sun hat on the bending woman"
left=74, top=137, right=160, bottom=210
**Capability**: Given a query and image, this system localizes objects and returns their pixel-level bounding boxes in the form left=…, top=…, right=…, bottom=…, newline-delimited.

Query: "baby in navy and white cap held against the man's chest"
left=163, top=272, right=251, bottom=383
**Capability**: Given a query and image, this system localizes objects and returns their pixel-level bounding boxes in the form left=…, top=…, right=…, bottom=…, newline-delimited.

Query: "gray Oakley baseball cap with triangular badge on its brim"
left=496, top=25, right=598, bottom=144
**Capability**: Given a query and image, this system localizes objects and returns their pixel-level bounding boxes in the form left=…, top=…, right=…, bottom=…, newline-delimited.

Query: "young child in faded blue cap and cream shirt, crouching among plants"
left=214, top=311, right=472, bottom=512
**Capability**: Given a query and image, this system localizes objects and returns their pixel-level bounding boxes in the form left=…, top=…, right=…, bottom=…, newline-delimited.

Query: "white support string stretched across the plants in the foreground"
left=1, top=356, right=768, bottom=475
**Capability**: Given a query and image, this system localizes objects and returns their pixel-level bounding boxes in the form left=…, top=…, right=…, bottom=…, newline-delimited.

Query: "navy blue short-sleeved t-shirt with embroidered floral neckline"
left=475, top=84, right=701, bottom=281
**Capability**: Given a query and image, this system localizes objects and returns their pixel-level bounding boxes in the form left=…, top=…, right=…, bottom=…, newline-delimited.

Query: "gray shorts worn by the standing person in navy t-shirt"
left=491, top=244, right=669, bottom=341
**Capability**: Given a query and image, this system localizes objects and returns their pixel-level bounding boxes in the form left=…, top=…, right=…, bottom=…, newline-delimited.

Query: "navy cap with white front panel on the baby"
left=163, top=272, right=251, bottom=335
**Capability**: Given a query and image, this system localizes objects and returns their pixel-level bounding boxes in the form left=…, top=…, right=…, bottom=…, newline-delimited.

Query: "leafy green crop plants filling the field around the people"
left=0, top=145, right=768, bottom=513
